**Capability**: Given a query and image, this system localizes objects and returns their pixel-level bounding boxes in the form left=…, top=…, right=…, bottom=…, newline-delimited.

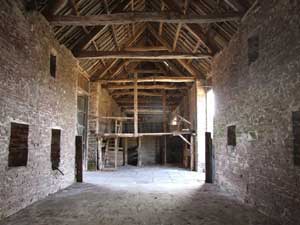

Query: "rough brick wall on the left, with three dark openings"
left=0, top=1, right=78, bottom=218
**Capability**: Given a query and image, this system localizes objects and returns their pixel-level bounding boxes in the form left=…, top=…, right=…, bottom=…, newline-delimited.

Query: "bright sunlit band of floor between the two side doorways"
left=84, top=166, right=205, bottom=192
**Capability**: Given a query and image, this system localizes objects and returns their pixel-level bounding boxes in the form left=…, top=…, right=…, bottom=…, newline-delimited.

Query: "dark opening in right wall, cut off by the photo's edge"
left=292, top=111, right=300, bottom=166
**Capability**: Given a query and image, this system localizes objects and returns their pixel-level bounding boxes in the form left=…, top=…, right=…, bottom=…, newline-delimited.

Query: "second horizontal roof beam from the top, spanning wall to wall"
left=75, top=51, right=211, bottom=60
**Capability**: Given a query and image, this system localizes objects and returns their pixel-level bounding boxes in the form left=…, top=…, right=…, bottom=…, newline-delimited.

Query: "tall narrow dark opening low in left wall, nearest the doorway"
left=51, top=129, right=61, bottom=170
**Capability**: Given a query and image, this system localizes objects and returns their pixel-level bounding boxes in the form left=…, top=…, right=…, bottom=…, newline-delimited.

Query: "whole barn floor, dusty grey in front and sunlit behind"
left=0, top=167, right=277, bottom=225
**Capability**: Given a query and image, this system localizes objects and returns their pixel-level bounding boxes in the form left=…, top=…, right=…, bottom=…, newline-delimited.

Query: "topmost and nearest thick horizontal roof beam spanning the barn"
left=49, top=12, right=241, bottom=26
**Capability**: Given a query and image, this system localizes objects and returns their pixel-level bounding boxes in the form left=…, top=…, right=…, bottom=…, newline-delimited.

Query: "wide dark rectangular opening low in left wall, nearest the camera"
left=8, top=123, right=29, bottom=167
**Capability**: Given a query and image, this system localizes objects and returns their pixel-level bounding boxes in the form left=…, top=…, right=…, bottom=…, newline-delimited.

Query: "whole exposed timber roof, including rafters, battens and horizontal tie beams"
left=41, top=0, right=255, bottom=113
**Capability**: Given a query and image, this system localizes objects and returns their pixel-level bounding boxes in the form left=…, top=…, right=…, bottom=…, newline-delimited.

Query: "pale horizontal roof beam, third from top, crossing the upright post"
left=101, top=76, right=195, bottom=84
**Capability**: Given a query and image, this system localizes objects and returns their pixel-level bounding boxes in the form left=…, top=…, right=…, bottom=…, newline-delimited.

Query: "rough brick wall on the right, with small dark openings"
left=212, top=0, right=300, bottom=224
